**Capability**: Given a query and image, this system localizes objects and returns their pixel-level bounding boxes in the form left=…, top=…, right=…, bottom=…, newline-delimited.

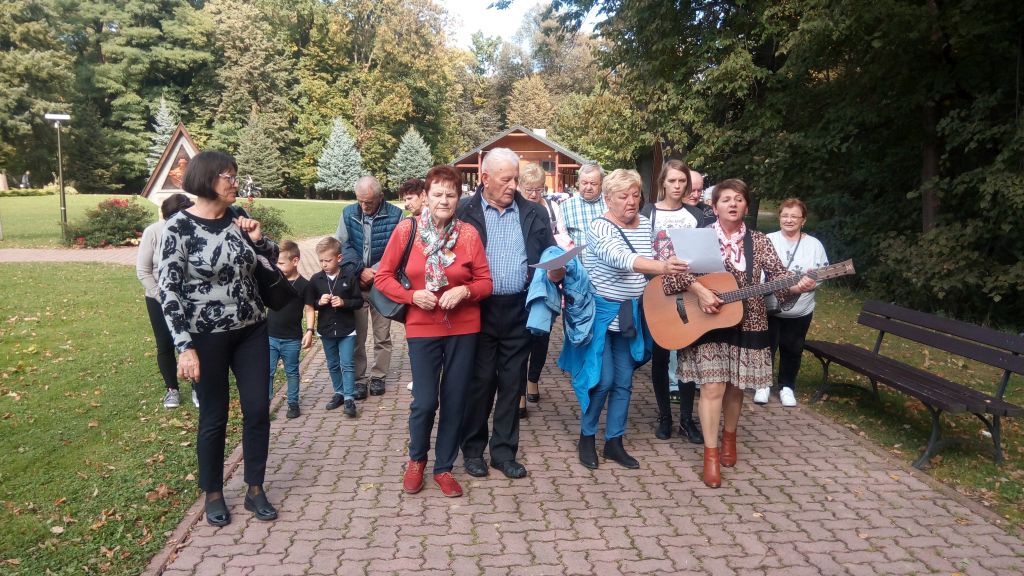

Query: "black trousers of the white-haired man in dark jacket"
left=462, top=293, right=530, bottom=463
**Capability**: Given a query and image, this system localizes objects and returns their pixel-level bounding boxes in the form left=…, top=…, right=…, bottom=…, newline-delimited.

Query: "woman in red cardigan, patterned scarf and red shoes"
left=374, top=166, right=492, bottom=497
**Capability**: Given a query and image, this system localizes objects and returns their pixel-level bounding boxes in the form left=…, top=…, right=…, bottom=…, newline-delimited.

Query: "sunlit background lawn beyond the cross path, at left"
left=0, top=194, right=349, bottom=248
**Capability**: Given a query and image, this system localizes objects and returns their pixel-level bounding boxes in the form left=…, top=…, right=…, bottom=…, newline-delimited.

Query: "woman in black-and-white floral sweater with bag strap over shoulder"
left=159, top=152, right=278, bottom=526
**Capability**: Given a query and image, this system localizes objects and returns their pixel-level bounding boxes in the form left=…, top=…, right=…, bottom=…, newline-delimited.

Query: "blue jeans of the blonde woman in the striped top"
left=580, top=332, right=635, bottom=440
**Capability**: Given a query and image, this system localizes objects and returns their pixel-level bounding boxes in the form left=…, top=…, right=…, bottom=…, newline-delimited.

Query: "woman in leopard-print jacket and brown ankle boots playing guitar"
left=665, top=178, right=816, bottom=488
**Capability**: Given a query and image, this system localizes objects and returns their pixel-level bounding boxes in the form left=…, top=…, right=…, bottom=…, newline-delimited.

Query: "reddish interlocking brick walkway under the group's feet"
left=146, top=326, right=1024, bottom=576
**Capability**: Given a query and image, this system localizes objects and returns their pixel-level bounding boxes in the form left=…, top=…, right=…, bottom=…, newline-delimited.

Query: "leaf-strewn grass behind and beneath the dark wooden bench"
left=798, top=286, right=1024, bottom=527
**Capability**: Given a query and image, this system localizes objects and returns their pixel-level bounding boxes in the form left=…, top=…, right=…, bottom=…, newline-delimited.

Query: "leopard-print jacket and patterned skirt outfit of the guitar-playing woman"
left=665, top=231, right=795, bottom=388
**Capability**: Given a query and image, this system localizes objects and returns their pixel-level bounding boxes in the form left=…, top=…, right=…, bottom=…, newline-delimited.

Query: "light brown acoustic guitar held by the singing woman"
left=643, top=260, right=855, bottom=349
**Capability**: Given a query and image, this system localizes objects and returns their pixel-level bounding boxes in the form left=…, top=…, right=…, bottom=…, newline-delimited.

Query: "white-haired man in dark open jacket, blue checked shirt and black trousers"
left=458, top=148, right=561, bottom=479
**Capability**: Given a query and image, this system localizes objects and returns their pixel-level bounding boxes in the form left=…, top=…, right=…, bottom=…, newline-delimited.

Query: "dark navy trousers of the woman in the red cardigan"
left=408, top=334, right=477, bottom=474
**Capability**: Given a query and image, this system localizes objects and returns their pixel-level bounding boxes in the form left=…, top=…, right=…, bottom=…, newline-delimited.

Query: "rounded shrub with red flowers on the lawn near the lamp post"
left=68, top=198, right=153, bottom=248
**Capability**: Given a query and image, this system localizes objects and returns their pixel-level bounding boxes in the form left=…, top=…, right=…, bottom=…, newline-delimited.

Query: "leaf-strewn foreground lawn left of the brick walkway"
left=0, top=264, right=240, bottom=575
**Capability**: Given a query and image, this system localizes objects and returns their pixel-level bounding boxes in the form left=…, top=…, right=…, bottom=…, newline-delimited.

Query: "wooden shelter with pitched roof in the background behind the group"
left=452, top=125, right=586, bottom=192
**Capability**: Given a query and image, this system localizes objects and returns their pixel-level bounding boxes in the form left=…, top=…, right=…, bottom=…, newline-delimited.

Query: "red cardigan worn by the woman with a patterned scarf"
left=374, top=218, right=494, bottom=338
